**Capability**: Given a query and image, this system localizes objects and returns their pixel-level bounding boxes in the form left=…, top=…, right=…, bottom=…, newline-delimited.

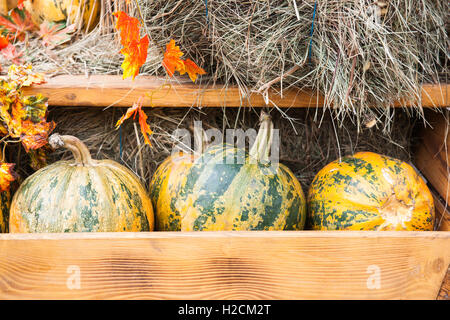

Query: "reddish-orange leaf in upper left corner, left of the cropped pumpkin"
left=0, top=8, right=36, bottom=41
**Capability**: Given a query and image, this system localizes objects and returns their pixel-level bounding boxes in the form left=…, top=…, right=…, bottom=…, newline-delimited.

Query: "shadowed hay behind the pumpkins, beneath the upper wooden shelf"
left=8, top=107, right=418, bottom=191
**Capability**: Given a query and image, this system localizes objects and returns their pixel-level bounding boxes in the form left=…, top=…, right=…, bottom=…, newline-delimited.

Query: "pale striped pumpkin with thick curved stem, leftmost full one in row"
left=9, top=134, right=154, bottom=233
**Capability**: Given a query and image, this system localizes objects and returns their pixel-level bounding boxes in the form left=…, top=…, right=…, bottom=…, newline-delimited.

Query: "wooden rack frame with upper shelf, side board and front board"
left=0, top=76, right=450, bottom=299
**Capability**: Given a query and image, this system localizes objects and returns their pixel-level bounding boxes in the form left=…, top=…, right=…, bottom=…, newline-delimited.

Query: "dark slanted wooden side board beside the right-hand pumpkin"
left=414, top=114, right=450, bottom=203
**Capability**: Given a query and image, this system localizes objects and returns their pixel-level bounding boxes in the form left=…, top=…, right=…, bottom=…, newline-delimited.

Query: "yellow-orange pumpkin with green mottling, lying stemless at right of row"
left=308, top=152, right=434, bottom=231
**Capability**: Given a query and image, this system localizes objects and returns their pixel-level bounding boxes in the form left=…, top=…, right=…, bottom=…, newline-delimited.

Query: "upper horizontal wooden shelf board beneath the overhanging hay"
left=20, top=75, right=450, bottom=108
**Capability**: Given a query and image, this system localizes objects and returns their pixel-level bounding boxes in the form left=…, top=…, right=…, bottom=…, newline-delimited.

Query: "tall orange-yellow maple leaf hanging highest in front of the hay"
left=113, top=11, right=149, bottom=80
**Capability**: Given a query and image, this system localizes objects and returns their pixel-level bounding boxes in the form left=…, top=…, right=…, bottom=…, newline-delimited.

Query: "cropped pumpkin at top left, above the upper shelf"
left=24, top=0, right=100, bottom=30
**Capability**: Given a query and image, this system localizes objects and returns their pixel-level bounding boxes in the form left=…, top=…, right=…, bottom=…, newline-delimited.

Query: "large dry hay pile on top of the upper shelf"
left=14, top=0, right=449, bottom=124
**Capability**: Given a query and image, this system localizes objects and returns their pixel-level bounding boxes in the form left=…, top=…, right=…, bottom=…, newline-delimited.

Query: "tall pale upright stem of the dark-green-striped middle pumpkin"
left=250, top=111, right=273, bottom=163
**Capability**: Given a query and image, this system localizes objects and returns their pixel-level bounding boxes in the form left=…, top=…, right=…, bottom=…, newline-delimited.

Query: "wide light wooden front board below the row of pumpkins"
left=0, top=231, right=450, bottom=300
